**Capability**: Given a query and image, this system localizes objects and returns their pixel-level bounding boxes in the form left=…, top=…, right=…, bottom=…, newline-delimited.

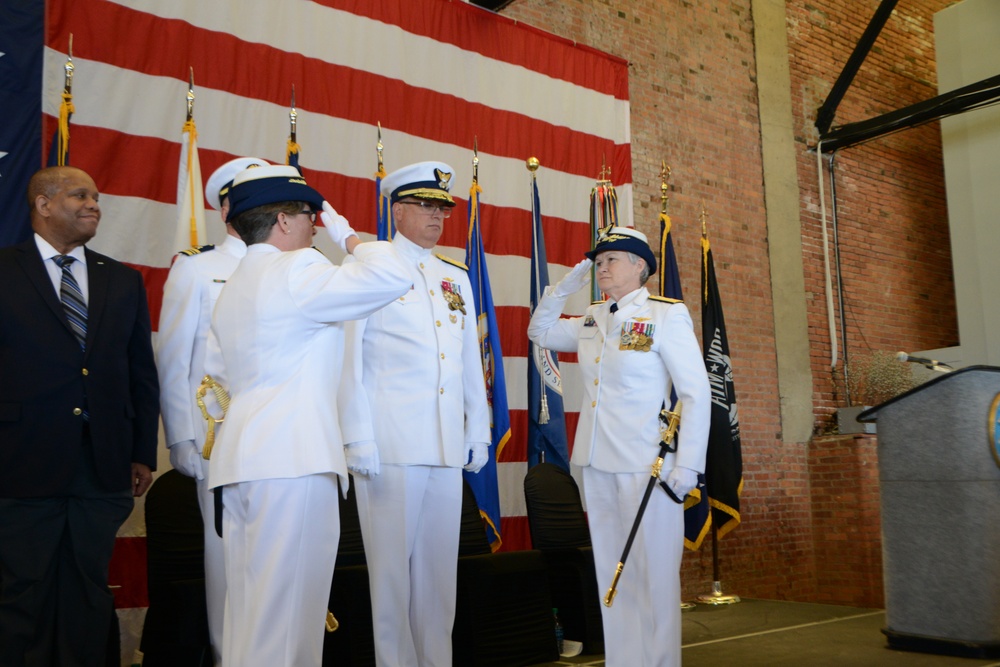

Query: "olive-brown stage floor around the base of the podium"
left=536, top=600, right=1000, bottom=667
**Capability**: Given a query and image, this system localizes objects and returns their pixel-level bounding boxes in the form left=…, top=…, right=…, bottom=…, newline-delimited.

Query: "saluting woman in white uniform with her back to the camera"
left=208, top=166, right=411, bottom=667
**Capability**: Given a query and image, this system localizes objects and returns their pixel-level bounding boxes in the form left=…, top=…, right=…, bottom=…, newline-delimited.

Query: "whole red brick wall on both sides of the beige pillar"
left=502, top=0, right=958, bottom=605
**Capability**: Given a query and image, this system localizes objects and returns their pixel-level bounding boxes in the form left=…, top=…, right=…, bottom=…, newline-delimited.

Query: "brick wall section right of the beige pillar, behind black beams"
left=786, top=0, right=958, bottom=430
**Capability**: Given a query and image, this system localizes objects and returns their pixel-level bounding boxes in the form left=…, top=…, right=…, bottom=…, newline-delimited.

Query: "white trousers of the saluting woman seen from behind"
left=222, top=473, right=340, bottom=667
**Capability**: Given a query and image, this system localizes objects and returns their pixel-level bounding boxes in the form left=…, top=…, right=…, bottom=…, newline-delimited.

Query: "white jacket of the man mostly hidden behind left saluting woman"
left=156, top=234, right=247, bottom=451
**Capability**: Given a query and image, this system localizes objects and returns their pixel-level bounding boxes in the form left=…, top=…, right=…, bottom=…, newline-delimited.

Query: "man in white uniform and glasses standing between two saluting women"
left=340, top=162, right=490, bottom=667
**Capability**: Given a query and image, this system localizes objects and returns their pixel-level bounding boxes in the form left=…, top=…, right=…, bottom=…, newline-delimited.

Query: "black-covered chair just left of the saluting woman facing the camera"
left=524, top=463, right=604, bottom=655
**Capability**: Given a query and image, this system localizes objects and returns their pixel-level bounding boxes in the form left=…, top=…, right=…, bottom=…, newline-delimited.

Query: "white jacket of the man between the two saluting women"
left=340, top=234, right=490, bottom=468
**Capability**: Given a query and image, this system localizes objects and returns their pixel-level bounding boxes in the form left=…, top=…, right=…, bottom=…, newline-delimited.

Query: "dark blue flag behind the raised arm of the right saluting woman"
left=528, top=175, right=569, bottom=471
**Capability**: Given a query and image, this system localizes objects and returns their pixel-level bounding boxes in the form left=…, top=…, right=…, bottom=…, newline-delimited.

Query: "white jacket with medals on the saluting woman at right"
left=528, top=287, right=711, bottom=473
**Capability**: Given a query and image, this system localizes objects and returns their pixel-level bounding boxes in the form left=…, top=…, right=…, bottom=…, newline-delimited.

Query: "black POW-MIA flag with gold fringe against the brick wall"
left=701, top=235, right=743, bottom=537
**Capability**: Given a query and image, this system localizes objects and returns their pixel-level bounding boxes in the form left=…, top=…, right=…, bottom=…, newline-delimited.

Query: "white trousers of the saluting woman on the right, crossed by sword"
left=583, top=462, right=684, bottom=667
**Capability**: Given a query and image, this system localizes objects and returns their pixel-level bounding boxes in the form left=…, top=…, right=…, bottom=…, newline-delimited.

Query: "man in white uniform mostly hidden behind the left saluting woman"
left=156, top=157, right=268, bottom=663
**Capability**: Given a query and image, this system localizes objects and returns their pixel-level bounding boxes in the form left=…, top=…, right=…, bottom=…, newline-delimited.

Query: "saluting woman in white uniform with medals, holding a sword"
left=528, top=227, right=711, bottom=667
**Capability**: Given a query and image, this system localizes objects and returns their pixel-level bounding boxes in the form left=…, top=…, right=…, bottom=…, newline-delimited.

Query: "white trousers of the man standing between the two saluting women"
left=354, top=464, right=462, bottom=667
